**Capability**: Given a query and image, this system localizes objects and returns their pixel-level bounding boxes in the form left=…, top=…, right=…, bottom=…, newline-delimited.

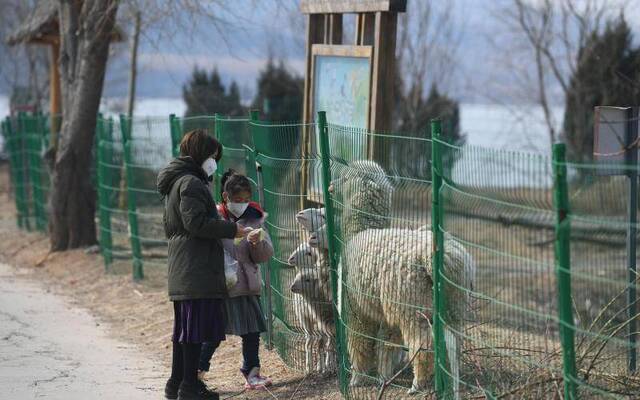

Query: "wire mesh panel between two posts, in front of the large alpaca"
left=318, top=115, right=433, bottom=399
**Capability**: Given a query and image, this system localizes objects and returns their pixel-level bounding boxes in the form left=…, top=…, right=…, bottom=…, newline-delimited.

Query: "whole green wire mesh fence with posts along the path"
left=2, top=113, right=640, bottom=399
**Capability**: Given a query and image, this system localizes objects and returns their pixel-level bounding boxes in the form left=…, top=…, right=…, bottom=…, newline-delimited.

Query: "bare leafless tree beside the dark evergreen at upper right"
left=494, top=0, right=626, bottom=148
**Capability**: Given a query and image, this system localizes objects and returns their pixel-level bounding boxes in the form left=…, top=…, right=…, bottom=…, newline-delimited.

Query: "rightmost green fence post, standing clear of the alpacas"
left=553, top=143, right=577, bottom=400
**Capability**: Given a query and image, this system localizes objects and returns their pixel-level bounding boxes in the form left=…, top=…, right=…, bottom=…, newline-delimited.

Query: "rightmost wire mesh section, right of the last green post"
left=558, top=161, right=640, bottom=399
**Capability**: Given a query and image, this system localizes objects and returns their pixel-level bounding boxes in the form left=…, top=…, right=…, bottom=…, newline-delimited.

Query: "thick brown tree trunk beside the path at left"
left=49, top=0, right=118, bottom=251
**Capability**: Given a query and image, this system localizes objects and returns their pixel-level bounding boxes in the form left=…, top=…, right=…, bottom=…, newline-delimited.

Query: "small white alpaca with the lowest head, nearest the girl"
left=291, top=265, right=336, bottom=373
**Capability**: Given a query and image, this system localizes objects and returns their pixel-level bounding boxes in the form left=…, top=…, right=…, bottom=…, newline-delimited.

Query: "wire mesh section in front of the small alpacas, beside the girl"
left=249, top=116, right=335, bottom=372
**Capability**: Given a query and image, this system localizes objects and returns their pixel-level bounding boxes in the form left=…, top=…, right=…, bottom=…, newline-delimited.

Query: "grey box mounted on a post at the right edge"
left=593, top=107, right=638, bottom=175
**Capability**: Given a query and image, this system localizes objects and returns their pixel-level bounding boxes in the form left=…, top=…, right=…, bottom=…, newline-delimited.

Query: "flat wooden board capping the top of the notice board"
left=300, top=0, right=407, bottom=14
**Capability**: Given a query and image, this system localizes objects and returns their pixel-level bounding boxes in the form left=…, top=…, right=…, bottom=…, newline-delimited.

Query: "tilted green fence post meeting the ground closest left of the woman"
left=120, top=114, right=144, bottom=280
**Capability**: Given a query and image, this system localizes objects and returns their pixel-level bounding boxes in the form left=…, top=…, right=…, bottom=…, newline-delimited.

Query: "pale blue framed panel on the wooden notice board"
left=309, top=45, right=373, bottom=202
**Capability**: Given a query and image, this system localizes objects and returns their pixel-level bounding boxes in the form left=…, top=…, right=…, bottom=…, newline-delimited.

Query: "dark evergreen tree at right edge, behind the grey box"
left=563, top=17, right=640, bottom=161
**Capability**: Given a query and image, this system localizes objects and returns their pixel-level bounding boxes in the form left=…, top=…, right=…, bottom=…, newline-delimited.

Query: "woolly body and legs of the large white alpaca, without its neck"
left=338, top=229, right=475, bottom=392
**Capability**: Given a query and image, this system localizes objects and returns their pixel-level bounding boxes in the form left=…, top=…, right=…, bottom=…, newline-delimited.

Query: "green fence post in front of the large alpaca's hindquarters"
left=431, top=120, right=451, bottom=398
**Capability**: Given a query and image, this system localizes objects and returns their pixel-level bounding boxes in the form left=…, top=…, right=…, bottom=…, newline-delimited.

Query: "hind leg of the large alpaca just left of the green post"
left=401, top=317, right=433, bottom=394
